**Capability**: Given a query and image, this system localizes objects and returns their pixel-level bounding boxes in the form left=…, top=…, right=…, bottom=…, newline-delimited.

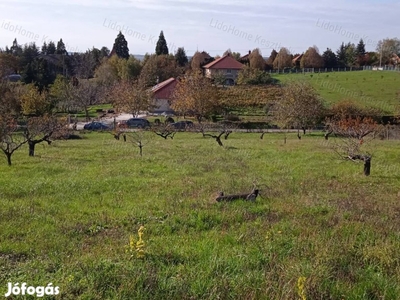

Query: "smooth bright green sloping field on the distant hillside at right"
left=273, top=71, right=400, bottom=114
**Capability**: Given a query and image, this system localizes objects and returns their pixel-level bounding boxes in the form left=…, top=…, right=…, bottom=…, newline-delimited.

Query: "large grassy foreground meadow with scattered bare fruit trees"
left=0, top=133, right=400, bottom=299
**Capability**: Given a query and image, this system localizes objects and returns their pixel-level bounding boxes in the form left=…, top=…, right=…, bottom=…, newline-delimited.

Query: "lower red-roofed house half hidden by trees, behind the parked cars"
left=151, top=77, right=177, bottom=113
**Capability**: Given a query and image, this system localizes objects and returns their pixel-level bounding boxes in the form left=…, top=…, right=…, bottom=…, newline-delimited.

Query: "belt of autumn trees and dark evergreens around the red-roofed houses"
left=0, top=31, right=398, bottom=171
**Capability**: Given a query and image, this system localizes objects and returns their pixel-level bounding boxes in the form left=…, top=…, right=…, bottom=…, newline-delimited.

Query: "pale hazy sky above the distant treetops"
left=0, top=0, right=400, bottom=56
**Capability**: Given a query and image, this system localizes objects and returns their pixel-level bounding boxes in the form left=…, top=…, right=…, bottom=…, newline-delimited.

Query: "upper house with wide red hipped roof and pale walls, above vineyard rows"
left=203, top=53, right=245, bottom=85
